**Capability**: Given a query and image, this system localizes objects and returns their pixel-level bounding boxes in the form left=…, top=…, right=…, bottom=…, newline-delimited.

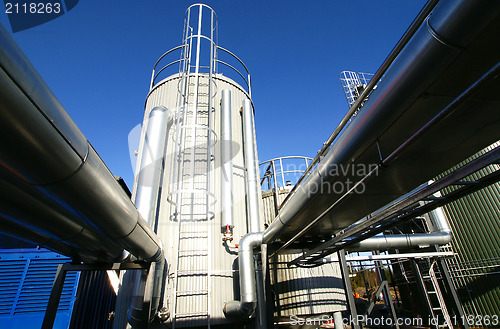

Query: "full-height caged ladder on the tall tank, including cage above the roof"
left=168, top=4, right=216, bottom=328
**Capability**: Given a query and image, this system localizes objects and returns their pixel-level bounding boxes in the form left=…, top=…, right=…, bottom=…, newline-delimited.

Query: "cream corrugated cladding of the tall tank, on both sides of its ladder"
left=139, top=75, right=264, bottom=327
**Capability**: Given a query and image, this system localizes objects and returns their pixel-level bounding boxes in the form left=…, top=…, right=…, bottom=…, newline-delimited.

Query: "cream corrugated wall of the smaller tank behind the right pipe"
left=262, top=186, right=347, bottom=317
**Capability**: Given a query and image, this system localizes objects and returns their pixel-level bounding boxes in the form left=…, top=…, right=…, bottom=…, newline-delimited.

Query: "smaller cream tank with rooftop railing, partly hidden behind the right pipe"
left=260, top=156, right=347, bottom=324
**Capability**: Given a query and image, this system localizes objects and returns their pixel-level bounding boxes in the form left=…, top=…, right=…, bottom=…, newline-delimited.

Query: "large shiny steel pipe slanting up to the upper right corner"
left=264, top=0, right=500, bottom=243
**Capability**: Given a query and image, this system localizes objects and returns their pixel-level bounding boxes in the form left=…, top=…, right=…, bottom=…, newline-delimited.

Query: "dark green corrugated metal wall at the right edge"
left=443, top=142, right=500, bottom=316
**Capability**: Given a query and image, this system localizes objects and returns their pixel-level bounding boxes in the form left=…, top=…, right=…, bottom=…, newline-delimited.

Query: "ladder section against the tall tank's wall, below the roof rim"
left=172, top=74, right=213, bottom=328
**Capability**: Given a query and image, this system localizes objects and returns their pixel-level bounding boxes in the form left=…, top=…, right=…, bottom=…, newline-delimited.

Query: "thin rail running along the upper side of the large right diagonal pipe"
left=278, top=0, right=439, bottom=210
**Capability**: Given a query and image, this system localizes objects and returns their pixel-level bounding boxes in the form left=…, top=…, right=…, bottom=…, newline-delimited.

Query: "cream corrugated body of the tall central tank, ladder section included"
left=136, top=74, right=264, bottom=327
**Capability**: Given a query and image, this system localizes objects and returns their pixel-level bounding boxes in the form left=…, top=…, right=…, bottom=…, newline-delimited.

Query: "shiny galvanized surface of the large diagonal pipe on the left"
left=0, top=23, right=160, bottom=262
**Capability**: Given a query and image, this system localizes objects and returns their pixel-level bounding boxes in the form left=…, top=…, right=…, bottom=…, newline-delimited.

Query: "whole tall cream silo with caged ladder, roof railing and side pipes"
left=118, top=4, right=264, bottom=328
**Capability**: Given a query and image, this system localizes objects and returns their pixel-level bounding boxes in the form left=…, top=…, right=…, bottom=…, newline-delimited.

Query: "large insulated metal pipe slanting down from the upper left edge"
left=0, top=23, right=162, bottom=261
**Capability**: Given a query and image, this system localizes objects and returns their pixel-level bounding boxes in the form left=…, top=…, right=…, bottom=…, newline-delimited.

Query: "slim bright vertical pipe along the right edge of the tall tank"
left=243, top=99, right=261, bottom=233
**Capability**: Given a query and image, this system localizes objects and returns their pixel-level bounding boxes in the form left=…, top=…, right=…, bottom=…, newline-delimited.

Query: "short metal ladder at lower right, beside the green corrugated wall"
left=416, top=260, right=453, bottom=329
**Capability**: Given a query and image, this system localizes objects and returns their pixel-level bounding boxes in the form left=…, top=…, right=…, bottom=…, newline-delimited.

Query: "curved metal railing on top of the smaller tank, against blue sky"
left=259, top=156, right=313, bottom=190
